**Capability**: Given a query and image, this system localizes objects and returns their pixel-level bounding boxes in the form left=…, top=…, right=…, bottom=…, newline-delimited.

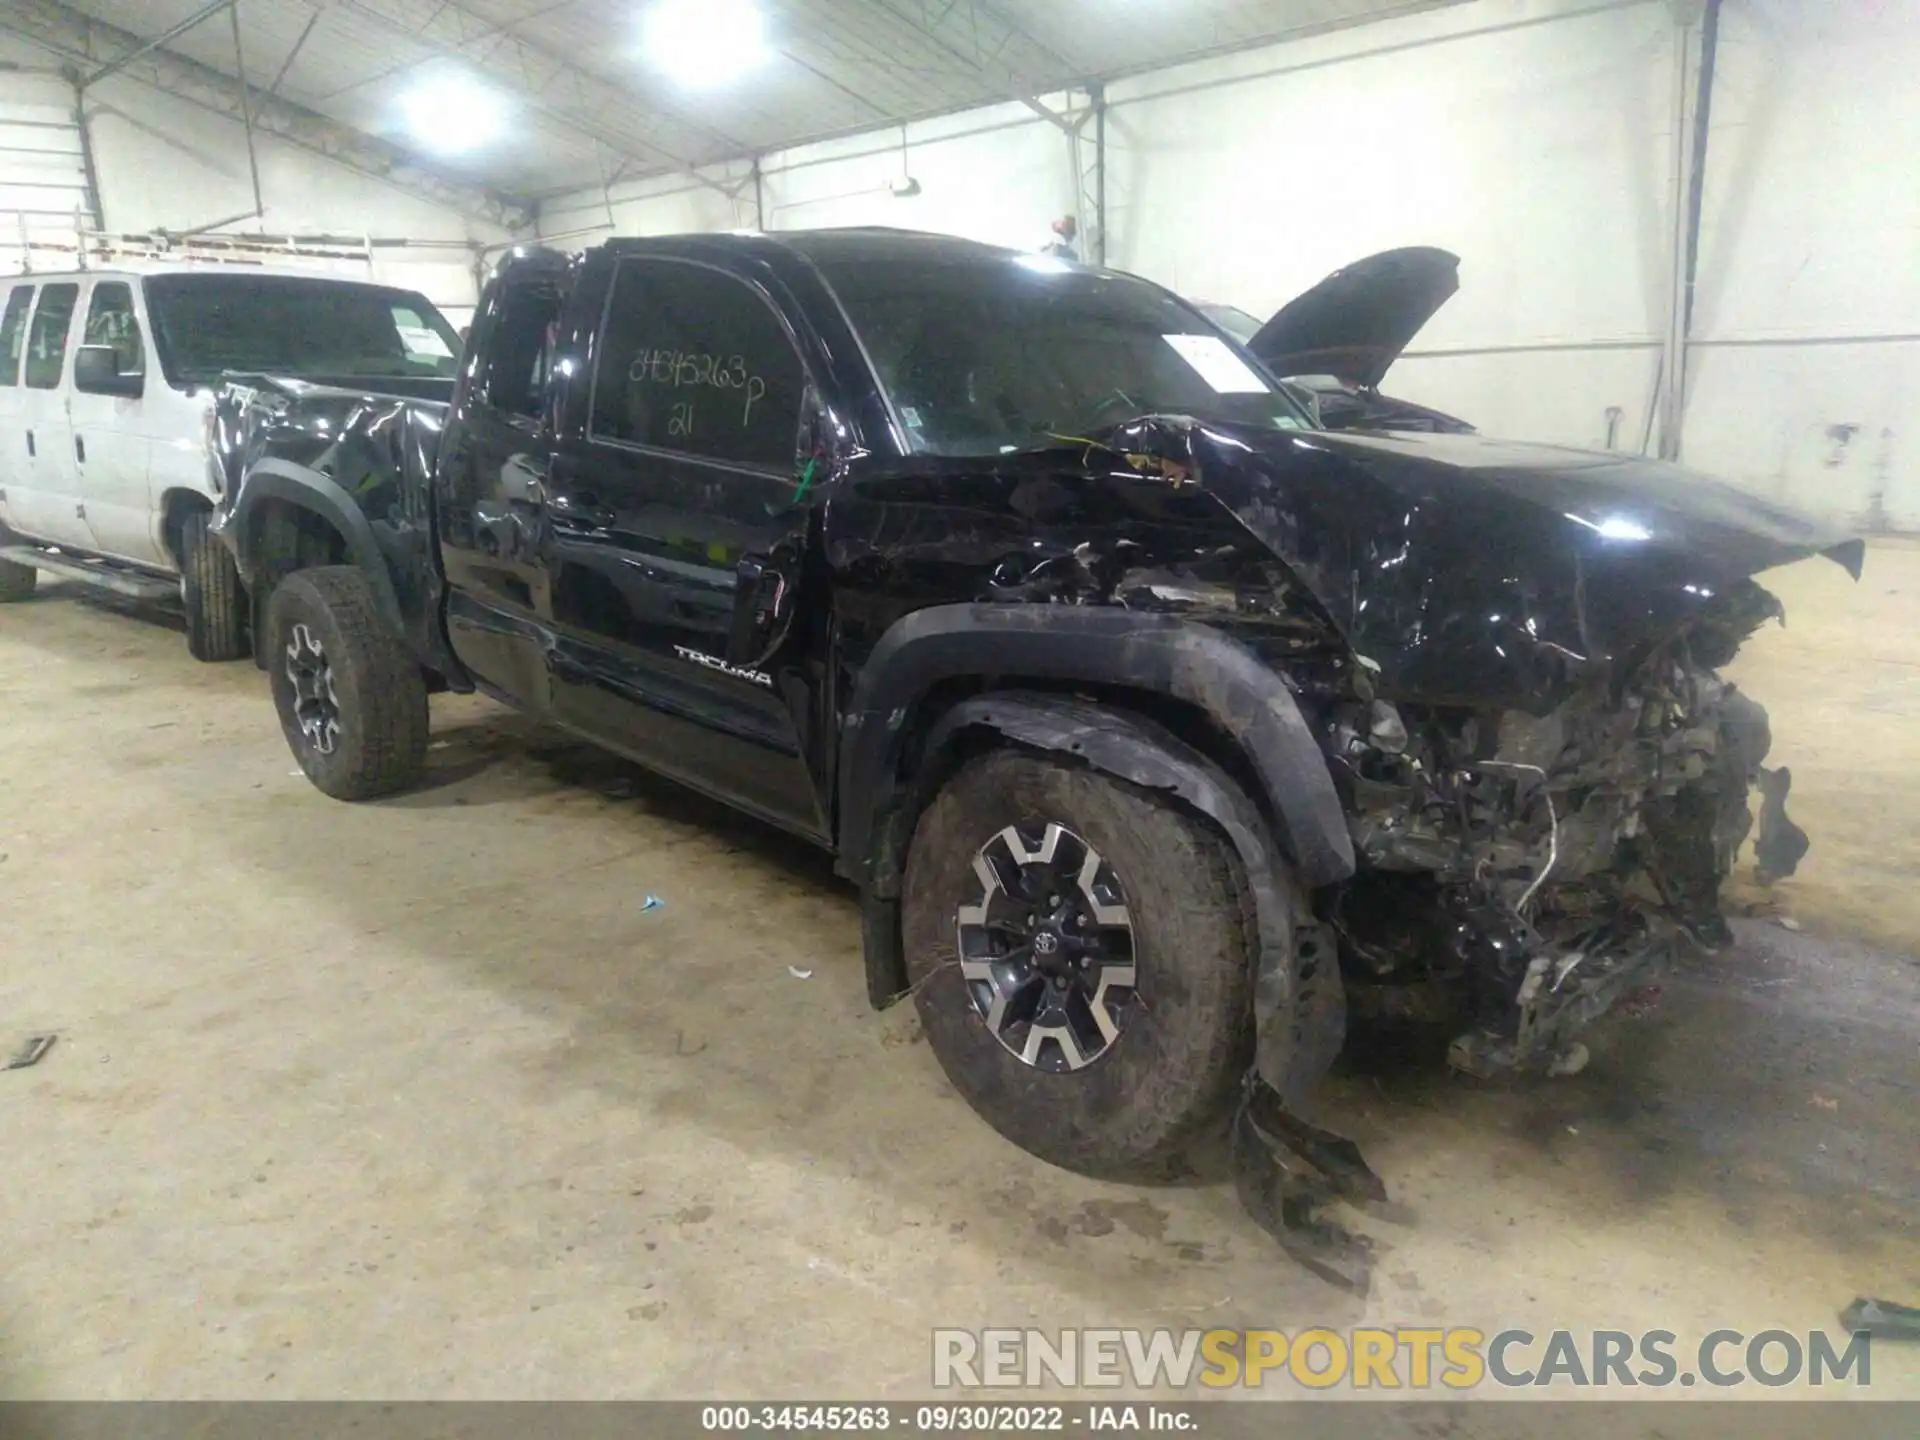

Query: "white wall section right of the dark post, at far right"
left=1684, top=0, right=1920, bottom=530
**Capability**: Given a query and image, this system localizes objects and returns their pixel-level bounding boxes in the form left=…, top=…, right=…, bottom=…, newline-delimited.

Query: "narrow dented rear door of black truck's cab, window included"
left=434, top=253, right=566, bottom=712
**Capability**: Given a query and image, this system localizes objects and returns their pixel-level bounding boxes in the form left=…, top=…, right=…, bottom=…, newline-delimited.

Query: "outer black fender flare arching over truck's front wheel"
left=837, top=605, right=1354, bottom=899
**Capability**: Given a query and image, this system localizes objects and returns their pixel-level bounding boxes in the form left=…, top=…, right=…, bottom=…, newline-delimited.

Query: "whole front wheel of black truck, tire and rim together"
left=902, top=751, right=1254, bottom=1177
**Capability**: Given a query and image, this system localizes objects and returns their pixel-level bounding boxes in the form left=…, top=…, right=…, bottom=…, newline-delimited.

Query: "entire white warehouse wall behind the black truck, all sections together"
left=522, top=0, right=1920, bottom=528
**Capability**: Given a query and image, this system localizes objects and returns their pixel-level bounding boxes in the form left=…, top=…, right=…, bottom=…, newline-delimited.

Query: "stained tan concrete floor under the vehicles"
left=0, top=545, right=1920, bottom=1398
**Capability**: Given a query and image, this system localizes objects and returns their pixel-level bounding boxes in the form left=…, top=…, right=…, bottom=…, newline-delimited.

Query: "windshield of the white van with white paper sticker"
left=146, top=275, right=461, bottom=384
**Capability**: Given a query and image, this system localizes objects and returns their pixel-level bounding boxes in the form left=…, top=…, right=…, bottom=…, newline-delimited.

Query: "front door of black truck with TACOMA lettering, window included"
left=547, top=255, right=826, bottom=837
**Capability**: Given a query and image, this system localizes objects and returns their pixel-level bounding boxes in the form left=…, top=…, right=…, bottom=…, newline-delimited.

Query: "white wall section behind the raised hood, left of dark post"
left=1108, top=0, right=1674, bottom=444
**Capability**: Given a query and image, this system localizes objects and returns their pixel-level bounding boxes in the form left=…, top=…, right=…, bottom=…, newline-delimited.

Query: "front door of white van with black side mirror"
left=69, top=280, right=164, bottom=568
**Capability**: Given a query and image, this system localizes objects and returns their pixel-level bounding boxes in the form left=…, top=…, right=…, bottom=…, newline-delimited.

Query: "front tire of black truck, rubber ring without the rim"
left=900, top=749, right=1258, bottom=1179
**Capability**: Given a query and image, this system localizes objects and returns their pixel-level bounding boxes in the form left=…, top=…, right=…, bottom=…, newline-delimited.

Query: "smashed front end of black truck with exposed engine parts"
left=1323, top=568, right=1797, bottom=1073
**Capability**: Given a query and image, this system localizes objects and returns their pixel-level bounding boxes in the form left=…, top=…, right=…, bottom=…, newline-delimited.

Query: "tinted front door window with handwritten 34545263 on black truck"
left=593, top=261, right=806, bottom=470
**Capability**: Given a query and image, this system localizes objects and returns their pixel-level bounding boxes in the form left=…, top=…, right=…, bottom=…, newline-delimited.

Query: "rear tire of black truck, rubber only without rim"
left=267, top=564, right=428, bottom=801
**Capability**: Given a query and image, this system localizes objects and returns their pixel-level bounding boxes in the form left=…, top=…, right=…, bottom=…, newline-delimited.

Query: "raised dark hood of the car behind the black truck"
left=1246, top=246, right=1459, bottom=390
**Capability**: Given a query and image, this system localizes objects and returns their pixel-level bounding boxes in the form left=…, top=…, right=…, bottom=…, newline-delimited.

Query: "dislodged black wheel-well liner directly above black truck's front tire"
left=906, top=689, right=1346, bottom=1112
